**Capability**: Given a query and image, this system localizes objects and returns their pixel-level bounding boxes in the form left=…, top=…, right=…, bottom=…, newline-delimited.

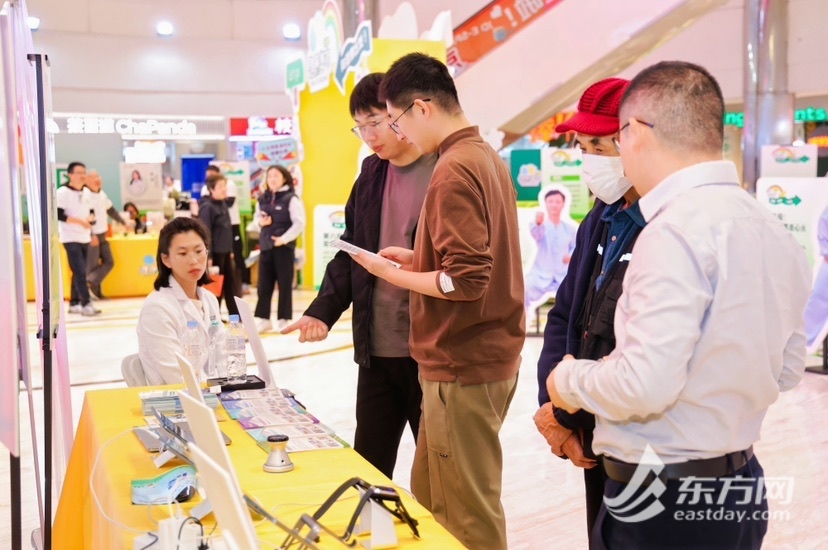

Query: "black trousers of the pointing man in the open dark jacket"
left=354, top=357, right=423, bottom=478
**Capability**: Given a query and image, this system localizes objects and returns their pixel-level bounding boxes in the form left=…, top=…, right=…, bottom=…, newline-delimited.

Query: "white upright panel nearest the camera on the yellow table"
left=190, top=444, right=259, bottom=548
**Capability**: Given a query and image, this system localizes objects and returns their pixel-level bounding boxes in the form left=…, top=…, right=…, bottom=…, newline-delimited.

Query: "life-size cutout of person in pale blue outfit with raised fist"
left=524, top=189, right=577, bottom=316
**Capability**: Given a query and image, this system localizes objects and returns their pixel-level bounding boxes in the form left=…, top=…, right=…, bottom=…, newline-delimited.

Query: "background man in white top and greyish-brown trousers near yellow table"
left=84, top=170, right=127, bottom=300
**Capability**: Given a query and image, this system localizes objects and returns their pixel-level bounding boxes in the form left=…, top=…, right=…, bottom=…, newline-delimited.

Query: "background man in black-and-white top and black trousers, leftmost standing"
left=56, top=162, right=100, bottom=317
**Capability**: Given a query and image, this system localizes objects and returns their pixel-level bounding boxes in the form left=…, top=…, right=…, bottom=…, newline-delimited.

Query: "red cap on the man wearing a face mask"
left=555, top=78, right=630, bottom=136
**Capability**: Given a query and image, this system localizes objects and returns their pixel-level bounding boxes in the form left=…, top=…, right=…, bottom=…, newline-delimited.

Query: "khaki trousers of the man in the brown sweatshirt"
left=411, top=377, right=517, bottom=550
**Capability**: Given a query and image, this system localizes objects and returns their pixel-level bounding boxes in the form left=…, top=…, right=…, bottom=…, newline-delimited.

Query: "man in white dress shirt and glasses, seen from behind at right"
left=546, top=61, right=811, bottom=549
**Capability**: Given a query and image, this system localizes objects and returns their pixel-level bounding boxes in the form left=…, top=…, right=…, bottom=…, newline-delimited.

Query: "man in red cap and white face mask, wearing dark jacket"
left=535, top=78, right=645, bottom=538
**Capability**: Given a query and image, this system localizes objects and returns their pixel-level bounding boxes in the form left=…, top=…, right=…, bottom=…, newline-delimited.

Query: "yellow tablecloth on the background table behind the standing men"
left=23, top=234, right=158, bottom=300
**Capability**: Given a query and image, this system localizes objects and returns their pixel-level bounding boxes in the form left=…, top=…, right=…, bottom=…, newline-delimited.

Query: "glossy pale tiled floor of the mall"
left=0, top=292, right=828, bottom=549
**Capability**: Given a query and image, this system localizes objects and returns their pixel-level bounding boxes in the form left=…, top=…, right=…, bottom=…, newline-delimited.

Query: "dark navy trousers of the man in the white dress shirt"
left=590, top=456, right=768, bottom=550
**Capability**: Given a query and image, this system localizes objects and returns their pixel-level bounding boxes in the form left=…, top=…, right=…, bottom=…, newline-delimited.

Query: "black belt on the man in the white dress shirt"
left=602, top=445, right=753, bottom=487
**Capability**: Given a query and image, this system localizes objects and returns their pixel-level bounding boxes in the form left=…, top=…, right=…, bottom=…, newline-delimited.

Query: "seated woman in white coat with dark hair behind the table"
left=137, top=218, right=221, bottom=386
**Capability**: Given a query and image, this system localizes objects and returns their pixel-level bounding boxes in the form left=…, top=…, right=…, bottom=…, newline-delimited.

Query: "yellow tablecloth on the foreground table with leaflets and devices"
left=52, top=388, right=463, bottom=550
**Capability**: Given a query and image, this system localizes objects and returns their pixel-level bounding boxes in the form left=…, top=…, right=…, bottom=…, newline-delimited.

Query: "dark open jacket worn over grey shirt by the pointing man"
left=305, top=155, right=406, bottom=367
